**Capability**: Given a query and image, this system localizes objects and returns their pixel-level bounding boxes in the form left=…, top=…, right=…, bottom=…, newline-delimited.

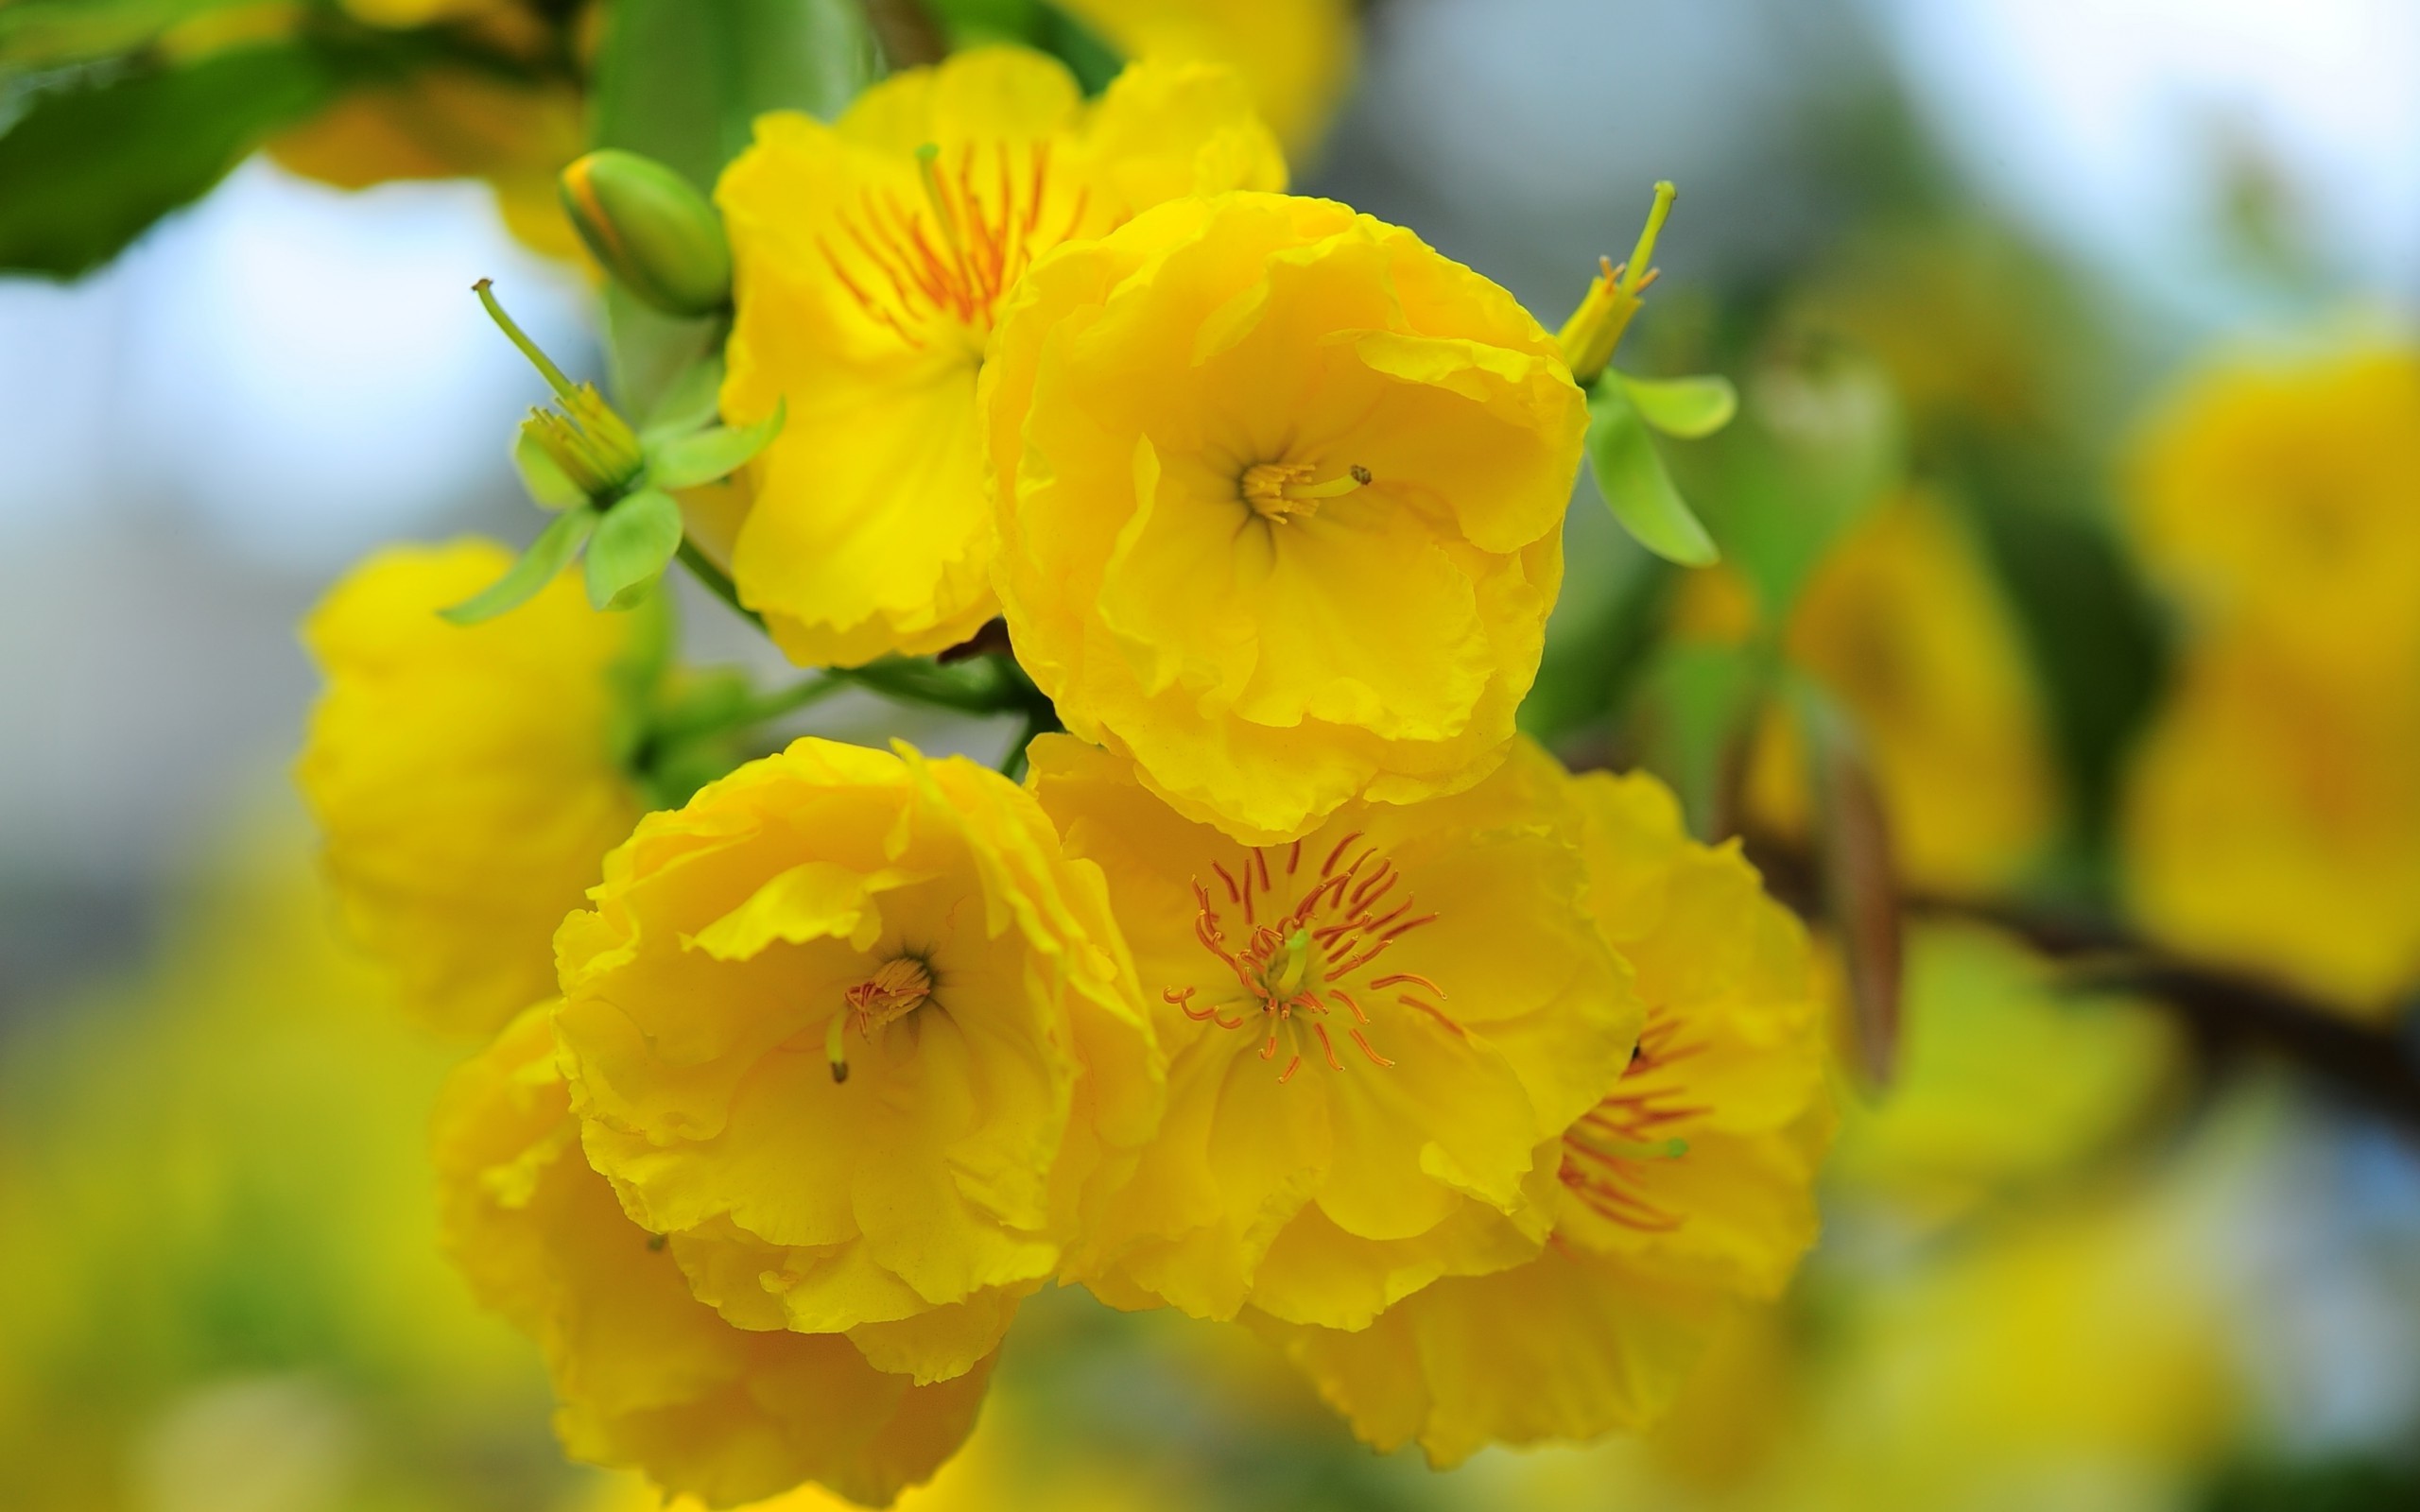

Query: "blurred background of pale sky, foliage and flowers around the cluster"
left=0, top=0, right=2420, bottom=1512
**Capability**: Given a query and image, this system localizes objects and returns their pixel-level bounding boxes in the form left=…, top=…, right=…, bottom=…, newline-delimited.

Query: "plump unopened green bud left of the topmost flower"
left=562, top=147, right=731, bottom=315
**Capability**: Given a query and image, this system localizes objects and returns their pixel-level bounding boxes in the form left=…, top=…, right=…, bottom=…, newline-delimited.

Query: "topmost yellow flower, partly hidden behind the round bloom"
left=717, top=48, right=1285, bottom=665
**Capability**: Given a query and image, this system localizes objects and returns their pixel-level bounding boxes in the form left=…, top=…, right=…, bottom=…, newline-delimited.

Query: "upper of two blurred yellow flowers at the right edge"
left=2132, top=349, right=2420, bottom=668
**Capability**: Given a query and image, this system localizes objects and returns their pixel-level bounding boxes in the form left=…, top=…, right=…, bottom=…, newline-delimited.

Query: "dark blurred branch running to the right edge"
left=1742, top=834, right=2420, bottom=1132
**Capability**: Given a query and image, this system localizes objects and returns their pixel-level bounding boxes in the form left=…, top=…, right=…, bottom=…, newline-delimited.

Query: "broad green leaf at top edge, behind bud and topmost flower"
left=593, top=0, right=873, bottom=194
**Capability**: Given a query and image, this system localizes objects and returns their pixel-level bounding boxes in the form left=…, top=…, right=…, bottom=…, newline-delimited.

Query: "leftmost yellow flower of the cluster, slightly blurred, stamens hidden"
left=295, top=540, right=639, bottom=1033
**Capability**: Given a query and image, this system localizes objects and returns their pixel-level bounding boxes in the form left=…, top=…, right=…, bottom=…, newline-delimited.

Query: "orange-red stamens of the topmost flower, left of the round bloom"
left=816, top=143, right=1089, bottom=355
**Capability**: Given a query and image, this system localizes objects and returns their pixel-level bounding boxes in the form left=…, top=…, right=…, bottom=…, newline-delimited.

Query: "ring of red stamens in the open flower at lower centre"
left=1162, top=833, right=1461, bottom=1081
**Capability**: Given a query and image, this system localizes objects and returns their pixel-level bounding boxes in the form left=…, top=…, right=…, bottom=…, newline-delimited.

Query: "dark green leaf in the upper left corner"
left=0, top=43, right=337, bottom=278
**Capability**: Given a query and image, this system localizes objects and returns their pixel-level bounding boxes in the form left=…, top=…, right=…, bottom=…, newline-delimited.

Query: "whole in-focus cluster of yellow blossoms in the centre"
left=300, top=48, right=1829, bottom=1504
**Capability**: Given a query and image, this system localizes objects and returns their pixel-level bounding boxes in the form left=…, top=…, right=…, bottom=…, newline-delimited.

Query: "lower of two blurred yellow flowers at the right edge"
left=2125, top=633, right=2420, bottom=1016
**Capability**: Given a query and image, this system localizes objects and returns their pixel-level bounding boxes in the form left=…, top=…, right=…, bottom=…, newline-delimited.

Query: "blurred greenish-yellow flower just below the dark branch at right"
left=1829, top=924, right=2183, bottom=1224
